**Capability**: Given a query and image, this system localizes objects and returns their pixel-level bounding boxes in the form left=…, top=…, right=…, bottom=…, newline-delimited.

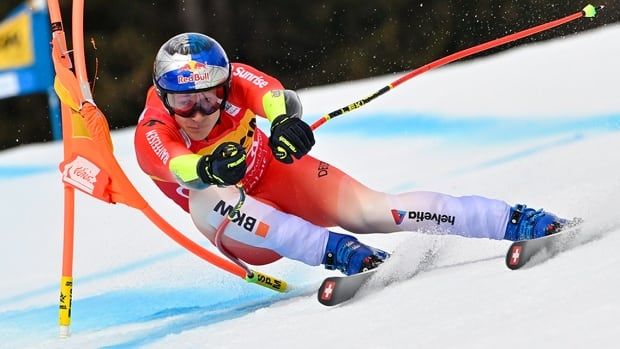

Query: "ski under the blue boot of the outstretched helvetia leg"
left=506, top=220, right=581, bottom=270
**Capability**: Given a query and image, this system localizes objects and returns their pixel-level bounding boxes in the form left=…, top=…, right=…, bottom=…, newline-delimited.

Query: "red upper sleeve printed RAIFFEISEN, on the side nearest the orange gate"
left=134, top=88, right=192, bottom=183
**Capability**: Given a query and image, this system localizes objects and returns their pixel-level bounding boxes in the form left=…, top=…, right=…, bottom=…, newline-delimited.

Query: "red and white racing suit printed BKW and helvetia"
left=135, top=63, right=509, bottom=265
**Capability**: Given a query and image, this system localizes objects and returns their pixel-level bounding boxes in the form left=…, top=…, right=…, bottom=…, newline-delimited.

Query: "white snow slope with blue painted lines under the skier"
left=0, top=25, right=620, bottom=349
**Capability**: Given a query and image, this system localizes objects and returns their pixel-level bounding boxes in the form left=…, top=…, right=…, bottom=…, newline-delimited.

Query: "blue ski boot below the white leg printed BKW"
left=323, top=231, right=390, bottom=275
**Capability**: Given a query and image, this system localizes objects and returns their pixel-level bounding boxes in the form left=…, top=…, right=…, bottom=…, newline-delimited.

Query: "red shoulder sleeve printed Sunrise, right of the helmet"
left=231, top=63, right=284, bottom=117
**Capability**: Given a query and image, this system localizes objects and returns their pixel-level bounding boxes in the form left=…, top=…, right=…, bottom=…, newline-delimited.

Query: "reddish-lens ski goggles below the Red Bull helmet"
left=166, top=89, right=221, bottom=118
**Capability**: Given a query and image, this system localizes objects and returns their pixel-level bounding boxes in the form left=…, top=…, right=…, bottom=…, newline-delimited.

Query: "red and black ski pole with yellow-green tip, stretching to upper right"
left=311, top=5, right=605, bottom=130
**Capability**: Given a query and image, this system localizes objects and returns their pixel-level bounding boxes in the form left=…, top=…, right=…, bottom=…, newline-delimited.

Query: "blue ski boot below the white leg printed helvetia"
left=504, top=205, right=568, bottom=241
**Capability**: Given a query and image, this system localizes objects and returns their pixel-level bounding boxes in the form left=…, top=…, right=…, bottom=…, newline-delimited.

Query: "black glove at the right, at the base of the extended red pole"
left=269, top=114, right=314, bottom=164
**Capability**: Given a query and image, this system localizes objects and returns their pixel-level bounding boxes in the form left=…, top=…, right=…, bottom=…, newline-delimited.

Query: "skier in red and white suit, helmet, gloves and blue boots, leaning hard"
left=135, top=33, right=567, bottom=275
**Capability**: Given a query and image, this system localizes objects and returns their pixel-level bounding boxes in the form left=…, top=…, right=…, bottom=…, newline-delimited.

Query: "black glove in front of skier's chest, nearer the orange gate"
left=197, top=142, right=247, bottom=185
